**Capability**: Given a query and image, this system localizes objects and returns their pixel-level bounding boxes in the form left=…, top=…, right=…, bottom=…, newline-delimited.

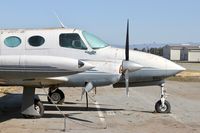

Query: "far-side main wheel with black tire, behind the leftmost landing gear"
left=47, top=89, right=65, bottom=104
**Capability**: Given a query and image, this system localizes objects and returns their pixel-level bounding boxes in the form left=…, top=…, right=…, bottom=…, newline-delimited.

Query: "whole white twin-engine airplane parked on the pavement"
left=0, top=22, right=185, bottom=117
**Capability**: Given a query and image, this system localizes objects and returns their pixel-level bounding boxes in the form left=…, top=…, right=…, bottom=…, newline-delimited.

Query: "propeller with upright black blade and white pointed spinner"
left=122, top=19, right=142, bottom=96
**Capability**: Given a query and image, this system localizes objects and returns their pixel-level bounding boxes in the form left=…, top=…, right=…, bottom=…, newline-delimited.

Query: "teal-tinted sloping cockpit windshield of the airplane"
left=83, top=31, right=109, bottom=49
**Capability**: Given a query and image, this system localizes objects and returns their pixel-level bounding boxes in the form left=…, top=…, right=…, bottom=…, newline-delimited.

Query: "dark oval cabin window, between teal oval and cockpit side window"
left=28, top=36, right=45, bottom=47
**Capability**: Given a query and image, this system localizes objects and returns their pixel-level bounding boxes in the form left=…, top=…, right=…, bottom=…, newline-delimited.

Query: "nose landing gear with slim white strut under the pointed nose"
left=155, top=84, right=171, bottom=113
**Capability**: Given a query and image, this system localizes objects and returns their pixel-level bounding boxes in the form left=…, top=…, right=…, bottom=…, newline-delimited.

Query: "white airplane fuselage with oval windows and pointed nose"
left=0, top=28, right=184, bottom=87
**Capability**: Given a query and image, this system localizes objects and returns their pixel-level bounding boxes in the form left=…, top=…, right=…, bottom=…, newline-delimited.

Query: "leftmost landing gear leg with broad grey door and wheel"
left=21, top=87, right=44, bottom=118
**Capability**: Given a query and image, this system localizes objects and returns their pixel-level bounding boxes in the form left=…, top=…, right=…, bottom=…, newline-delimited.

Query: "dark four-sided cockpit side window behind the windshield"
left=59, top=33, right=87, bottom=50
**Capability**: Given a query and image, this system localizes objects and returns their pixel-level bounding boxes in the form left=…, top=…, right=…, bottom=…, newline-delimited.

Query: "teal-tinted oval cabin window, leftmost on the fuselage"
left=4, top=36, right=21, bottom=47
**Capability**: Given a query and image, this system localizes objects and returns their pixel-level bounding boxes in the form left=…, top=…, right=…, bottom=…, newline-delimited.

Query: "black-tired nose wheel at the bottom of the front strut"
left=155, top=100, right=171, bottom=113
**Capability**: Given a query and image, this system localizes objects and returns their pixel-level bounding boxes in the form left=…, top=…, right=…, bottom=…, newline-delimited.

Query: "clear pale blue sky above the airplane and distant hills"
left=0, top=0, right=200, bottom=45
